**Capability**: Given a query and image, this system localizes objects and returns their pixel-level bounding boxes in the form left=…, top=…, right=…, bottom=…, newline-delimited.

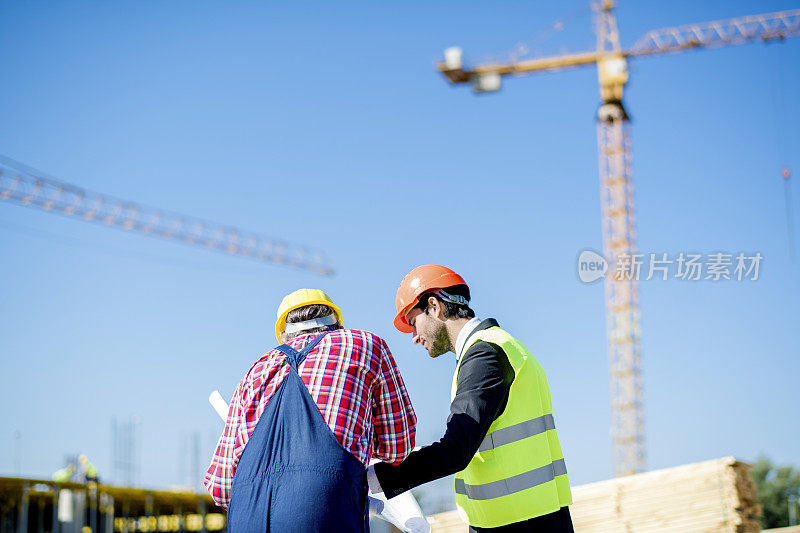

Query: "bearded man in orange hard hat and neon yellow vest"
left=368, top=265, right=573, bottom=533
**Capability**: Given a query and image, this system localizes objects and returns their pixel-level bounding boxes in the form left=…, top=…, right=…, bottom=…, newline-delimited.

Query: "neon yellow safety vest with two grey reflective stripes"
left=450, top=326, right=572, bottom=527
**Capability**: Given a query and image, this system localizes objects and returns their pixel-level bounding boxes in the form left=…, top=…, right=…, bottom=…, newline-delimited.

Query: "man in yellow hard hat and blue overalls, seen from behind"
left=204, top=289, right=416, bottom=533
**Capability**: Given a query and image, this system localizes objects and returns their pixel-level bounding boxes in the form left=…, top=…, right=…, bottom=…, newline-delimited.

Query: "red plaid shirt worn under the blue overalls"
left=203, top=329, right=417, bottom=508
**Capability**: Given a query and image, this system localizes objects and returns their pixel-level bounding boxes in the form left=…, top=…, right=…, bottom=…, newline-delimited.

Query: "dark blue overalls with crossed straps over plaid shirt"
left=227, top=333, right=369, bottom=533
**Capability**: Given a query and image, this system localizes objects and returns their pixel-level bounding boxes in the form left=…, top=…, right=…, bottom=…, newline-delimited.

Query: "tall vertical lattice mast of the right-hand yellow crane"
left=595, top=0, right=645, bottom=476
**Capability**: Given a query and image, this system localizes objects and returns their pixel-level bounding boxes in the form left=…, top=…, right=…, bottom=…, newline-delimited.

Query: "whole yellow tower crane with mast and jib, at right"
left=437, top=4, right=800, bottom=476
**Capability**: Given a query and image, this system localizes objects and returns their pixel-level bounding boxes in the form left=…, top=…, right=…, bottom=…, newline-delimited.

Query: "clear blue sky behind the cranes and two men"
left=0, top=0, right=800, bottom=502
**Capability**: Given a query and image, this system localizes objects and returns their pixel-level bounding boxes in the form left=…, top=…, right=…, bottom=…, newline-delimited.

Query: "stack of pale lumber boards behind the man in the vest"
left=429, top=457, right=761, bottom=533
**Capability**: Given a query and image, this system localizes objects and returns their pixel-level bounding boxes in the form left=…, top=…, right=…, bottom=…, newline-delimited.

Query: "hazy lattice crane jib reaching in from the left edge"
left=0, top=156, right=334, bottom=275
